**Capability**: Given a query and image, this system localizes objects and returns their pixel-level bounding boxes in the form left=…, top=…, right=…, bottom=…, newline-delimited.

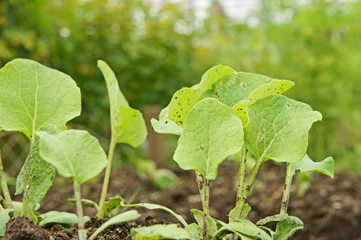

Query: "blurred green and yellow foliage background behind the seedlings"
left=0, top=0, right=361, bottom=172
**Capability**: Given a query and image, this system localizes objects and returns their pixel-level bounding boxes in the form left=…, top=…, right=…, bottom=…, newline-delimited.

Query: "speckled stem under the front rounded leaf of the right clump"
left=196, top=171, right=210, bottom=240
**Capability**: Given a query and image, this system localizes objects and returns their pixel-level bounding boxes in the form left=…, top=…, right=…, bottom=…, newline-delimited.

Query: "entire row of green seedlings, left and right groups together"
left=0, top=59, right=334, bottom=240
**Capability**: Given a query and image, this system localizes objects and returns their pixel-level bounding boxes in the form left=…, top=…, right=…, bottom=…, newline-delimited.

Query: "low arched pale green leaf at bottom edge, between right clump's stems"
left=213, top=219, right=272, bottom=240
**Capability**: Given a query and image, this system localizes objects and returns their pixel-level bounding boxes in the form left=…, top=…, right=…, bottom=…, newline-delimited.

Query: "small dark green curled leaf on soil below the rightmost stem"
left=274, top=216, right=303, bottom=240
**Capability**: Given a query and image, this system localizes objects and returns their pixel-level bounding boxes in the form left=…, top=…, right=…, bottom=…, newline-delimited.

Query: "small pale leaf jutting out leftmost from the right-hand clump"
left=150, top=107, right=183, bottom=135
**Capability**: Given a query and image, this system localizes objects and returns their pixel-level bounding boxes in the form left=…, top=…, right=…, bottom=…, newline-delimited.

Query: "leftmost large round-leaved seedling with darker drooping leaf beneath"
left=0, top=59, right=81, bottom=222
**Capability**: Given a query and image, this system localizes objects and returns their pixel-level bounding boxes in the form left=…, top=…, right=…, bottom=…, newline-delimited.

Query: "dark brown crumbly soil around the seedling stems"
left=6, top=162, right=361, bottom=240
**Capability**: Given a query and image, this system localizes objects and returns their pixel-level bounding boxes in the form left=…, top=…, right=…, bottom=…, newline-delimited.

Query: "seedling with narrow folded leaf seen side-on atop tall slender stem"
left=97, top=60, right=147, bottom=218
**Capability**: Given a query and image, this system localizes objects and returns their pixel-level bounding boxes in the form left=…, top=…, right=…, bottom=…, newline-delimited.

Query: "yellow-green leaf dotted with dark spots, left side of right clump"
left=168, top=88, right=203, bottom=127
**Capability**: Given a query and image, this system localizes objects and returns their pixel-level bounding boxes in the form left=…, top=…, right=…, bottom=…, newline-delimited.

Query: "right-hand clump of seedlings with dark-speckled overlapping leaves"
left=142, top=66, right=333, bottom=240
